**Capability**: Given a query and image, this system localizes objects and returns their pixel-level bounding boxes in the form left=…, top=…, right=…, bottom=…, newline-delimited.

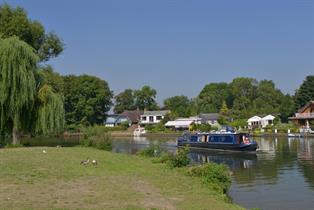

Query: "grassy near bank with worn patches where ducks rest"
left=0, top=147, right=241, bottom=209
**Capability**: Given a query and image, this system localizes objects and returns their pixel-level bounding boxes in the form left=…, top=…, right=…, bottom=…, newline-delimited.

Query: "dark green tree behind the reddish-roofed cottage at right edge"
left=295, top=75, right=314, bottom=109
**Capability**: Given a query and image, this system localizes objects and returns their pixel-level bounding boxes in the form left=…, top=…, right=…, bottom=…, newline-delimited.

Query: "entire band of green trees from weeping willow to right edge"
left=0, top=4, right=314, bottom=143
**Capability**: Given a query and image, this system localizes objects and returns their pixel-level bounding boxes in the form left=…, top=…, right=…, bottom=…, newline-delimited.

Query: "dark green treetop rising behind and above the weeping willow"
left=0, top=4, right=63, bottom=61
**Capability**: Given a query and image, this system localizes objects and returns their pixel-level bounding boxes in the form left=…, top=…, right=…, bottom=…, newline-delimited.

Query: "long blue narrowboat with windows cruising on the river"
left=177, top=132, right=258, bottom=152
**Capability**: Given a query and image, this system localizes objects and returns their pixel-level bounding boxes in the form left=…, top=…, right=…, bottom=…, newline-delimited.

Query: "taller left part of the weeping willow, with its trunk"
left=0, top=37, right=39, bottom=144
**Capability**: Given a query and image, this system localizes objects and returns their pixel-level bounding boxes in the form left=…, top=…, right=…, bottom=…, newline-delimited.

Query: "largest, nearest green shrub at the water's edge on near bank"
left=188, top=162, right=231, bottom=193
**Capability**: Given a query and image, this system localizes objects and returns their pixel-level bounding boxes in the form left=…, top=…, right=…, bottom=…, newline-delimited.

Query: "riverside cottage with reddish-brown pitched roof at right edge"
left=289, top=101, right=314, bottom=129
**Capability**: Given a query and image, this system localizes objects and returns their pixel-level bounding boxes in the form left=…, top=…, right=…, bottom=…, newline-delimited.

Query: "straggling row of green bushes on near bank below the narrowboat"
left=138, top=145, right=231, bottom=197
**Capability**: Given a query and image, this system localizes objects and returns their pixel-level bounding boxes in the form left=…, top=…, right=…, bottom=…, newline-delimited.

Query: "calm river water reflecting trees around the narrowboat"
left=20, top=137, right=314, bottom=210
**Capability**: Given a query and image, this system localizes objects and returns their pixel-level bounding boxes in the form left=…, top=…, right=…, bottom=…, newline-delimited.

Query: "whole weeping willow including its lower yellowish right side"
left=0, top=37, right=64, bottom=144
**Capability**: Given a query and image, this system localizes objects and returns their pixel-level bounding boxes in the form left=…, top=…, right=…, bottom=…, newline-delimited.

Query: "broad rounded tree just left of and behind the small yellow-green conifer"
left=198, top=82, right=232, bottom=113
